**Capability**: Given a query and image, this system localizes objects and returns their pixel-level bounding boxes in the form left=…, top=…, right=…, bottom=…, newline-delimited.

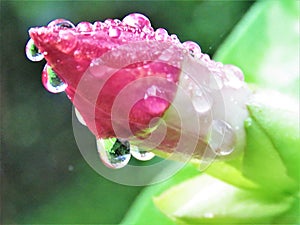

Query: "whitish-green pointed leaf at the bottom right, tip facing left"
left=155, top=174, right=293, bottom=224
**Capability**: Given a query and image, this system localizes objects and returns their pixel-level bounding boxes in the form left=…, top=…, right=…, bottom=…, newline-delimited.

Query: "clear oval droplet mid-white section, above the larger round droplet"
left=192, top=88, right=212, bottom=113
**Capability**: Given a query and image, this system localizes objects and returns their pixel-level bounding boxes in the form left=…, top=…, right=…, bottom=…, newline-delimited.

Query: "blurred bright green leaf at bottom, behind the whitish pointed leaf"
left=121, top=164, right=199, bottom=225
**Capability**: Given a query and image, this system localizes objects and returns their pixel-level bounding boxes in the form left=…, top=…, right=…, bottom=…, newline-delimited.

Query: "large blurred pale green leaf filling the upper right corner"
left=214, top=0, right=300, bottom=97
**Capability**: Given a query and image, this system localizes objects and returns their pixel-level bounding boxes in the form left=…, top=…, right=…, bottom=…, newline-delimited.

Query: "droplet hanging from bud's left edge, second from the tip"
left=42, top=64, right=68, bottom=93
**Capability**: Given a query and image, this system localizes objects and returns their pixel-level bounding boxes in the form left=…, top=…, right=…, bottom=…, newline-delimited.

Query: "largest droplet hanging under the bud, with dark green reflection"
left=97, top=138, right=131, bottom=169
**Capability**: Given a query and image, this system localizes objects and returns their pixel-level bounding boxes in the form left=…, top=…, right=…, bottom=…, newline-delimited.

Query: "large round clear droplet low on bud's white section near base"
left=208, top=120, right=236, bottom=156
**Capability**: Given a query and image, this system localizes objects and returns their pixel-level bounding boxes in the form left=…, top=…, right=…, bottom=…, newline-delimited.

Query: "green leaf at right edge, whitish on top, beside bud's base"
left=244, top=91, right=300, bottom=185
